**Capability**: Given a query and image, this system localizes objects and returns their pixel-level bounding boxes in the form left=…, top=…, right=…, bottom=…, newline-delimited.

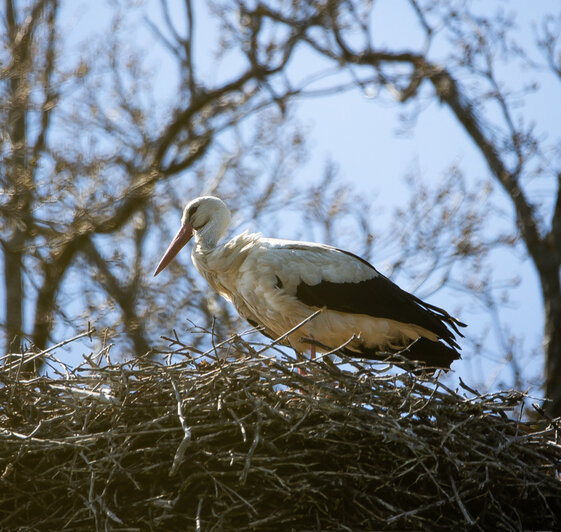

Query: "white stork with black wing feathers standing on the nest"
left=154, top=196, right=465, bottom=368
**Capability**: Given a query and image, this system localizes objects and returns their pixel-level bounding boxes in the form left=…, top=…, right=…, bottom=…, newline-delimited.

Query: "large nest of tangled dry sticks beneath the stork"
left=0, top=338, right=561, bottom=531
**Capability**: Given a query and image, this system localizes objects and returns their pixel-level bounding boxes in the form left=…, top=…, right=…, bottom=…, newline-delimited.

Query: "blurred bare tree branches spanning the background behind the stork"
left=0, top=0, right=561, bottom=415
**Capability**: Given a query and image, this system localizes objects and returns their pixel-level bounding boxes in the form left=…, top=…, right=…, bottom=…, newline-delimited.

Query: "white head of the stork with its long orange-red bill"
left=154, top=196, right=230, bottom=277
